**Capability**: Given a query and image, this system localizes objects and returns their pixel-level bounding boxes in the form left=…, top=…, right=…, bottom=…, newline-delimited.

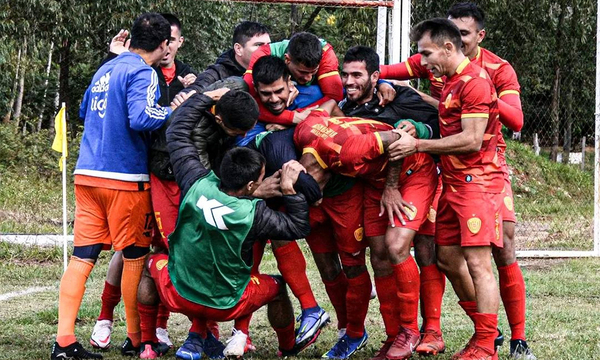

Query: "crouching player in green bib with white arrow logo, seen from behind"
left=135, top=94, right=316, bottom=357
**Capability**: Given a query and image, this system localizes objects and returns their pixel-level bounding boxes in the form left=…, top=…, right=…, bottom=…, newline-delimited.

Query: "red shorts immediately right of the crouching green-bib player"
left=306, top=181, right=368, bottom=254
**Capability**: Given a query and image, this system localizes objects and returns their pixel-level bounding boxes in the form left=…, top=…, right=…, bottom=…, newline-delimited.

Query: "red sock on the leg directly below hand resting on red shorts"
left=393, top=256, right=420, bottom=333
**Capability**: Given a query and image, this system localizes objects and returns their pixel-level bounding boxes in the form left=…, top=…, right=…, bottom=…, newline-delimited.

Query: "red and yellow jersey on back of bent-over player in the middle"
left=294, top=110, right=432, bottom=181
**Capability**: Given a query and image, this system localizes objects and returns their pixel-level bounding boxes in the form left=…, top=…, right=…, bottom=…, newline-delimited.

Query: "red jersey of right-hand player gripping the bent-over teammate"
left=438, top=59, right=504, bottom=193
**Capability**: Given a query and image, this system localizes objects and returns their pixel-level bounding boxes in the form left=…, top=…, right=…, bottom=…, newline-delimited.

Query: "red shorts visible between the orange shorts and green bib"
left=150, top=174, right=181, bottom=249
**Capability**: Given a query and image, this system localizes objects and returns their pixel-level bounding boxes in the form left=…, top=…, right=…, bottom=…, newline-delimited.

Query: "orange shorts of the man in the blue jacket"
left=73, top=184, right=154, bottom=251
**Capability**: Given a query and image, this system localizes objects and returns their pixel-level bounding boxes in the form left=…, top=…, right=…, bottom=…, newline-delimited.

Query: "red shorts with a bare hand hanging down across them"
left=364, top=159, right=437, bottom=237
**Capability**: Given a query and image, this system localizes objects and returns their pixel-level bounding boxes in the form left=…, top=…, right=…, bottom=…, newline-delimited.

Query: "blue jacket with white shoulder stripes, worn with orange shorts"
left=75, top=52, right=171, bottom=182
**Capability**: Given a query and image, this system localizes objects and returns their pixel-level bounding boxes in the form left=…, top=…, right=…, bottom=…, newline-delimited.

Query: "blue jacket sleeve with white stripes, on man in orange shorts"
left=127, top=67, right=173, bottom=131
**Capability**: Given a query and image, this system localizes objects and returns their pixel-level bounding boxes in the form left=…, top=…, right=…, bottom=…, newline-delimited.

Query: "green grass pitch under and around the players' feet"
left=0, top=243, right=600, bottom=360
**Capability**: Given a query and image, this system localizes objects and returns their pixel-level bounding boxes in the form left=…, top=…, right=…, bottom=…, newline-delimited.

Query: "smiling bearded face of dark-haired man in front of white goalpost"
left=342, top=61, right=379, bottom=104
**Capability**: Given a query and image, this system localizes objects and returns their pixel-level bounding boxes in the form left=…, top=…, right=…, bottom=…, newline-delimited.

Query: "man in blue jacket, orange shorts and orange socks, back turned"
left=51, top=13, right=172, bottom=359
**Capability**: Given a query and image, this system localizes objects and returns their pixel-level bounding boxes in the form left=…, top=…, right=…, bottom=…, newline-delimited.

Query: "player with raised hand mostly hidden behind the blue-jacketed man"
left=90, top=14, right=196, bottom=349
